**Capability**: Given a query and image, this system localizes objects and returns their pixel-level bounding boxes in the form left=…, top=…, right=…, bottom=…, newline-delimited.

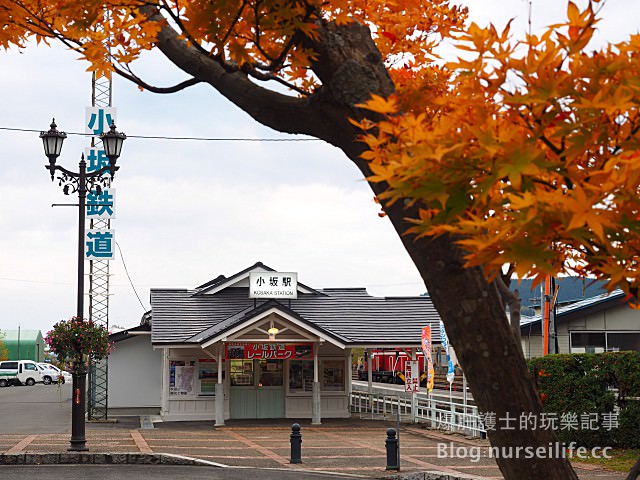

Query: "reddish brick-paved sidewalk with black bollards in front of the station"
left=0, top=417, right=625, bottom=480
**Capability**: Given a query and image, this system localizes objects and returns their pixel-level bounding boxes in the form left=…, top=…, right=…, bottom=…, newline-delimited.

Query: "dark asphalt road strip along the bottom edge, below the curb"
left=0, top=465, right=358, bottom=480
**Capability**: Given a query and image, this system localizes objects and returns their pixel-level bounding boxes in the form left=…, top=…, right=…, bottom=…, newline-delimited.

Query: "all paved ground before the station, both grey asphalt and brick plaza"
left=0, top=385, right=625, bottom=480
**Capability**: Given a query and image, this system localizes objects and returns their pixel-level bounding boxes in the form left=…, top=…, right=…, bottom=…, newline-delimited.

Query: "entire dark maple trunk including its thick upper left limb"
left=145, top=12, right=577, bottom=480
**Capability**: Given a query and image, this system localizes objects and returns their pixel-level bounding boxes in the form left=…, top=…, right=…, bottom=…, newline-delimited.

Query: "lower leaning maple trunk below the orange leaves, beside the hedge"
left=387, top=222, right=578, bottom=480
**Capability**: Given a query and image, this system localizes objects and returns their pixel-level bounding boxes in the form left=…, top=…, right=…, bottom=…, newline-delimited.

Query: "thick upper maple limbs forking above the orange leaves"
left=138, top=6, right=394, bottom=156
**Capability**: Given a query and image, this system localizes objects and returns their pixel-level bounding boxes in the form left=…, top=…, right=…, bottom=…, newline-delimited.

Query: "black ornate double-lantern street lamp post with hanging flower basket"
left=40, top=119, right=127, bottom=451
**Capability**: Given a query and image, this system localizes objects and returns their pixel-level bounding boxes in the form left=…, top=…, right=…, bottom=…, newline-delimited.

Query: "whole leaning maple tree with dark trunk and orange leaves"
left=0, top=0, right=640, bottom=480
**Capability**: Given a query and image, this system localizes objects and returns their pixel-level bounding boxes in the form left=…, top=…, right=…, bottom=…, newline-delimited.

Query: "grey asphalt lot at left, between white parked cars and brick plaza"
left=0, top=383, right=71, bottom=433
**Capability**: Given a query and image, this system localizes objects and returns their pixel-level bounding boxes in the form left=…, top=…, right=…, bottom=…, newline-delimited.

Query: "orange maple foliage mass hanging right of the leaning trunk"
left=358, top=2, right=640, bottom=296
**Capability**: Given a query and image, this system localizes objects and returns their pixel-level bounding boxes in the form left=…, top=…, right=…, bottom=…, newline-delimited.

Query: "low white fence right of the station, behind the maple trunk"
left=351, top=385, right=487, bottom=438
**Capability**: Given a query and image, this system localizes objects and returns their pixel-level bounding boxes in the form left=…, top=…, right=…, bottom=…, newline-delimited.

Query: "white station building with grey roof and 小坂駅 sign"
left=108, top=262, right=439, bottom=425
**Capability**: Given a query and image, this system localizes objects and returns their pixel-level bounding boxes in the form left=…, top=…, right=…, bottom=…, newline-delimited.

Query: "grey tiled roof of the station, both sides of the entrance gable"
left=151, top=288, right=440, bottom=346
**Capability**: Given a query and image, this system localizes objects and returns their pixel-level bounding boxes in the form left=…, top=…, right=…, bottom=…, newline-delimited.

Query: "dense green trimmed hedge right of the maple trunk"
left=529, top=351, right=640, bottom=448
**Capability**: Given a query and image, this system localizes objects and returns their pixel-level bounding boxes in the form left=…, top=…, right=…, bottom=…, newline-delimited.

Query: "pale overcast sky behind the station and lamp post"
left=0, top=0, right=640, bottom=334
